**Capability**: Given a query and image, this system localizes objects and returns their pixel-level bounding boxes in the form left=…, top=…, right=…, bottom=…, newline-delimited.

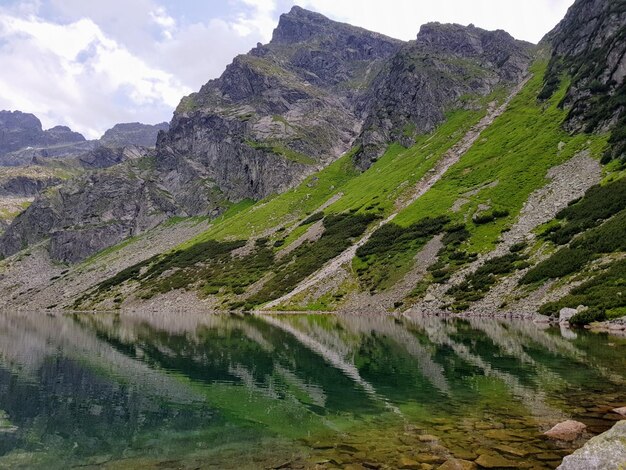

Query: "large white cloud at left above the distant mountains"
left=0, top=15, right=191, bottom=137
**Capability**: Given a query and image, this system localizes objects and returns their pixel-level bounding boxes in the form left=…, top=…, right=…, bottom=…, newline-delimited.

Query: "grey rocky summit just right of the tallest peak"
left=357, top=23, right=531, bottom=169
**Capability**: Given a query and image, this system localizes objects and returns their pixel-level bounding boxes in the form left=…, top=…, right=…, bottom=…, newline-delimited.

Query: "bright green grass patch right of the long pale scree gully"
left=395, top=62, right=607, bottom=258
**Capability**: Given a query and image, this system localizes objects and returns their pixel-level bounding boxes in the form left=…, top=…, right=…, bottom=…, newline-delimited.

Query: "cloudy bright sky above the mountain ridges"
left=0, top=0, right=573, bottom=138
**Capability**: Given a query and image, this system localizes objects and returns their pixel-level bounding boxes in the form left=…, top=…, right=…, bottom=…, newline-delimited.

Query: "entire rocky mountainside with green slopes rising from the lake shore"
left=0, top=0, right=626, bottom=324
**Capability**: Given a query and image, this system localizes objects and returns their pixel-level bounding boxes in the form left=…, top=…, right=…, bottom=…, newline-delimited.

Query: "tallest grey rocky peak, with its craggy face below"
left=163, top=7, right=401, bottom=200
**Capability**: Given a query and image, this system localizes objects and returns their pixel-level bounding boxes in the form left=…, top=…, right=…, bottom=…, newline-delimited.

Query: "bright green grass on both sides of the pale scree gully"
left=77, top=62, right=607, bottom=314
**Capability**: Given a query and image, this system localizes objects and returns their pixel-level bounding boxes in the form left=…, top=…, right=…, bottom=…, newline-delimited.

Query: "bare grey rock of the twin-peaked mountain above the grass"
left=0, top=7, right=531, bottom=262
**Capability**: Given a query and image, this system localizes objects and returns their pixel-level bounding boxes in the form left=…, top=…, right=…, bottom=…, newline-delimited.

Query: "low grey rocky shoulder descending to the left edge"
left=0, top=162, right=180, bottom=262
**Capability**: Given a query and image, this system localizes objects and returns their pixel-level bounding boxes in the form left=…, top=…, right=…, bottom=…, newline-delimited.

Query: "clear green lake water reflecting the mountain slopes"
left=0, top=312, right=626, bottom=469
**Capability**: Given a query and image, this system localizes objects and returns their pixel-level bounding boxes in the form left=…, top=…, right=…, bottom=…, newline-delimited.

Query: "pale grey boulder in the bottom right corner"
left=558, top=421, right=626, bottom=470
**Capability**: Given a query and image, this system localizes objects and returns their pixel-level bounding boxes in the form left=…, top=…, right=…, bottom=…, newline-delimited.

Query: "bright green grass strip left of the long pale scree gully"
left=182, top=105, right=484, bottom=248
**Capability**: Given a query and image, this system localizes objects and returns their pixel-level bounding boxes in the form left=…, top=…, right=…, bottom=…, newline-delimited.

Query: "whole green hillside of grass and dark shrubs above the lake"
left=74, top=57, right=624, bottom=316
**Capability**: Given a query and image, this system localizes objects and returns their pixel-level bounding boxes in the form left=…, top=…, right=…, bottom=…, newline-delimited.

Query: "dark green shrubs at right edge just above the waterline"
left=539, top=259, right=626, bottom=325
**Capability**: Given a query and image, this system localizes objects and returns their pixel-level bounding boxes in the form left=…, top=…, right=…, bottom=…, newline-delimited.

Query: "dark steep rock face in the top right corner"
left=541, top=0, right=626, bottom=160
